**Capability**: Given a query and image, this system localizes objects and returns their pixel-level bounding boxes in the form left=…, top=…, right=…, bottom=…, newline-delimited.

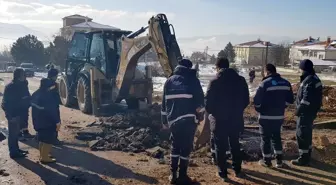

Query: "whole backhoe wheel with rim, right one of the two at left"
left=77, top=76, right=92, bottom=114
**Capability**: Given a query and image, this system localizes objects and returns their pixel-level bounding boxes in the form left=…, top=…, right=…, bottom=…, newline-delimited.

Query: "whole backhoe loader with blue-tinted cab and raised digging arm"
left=58, top=14, right=181, bottom=115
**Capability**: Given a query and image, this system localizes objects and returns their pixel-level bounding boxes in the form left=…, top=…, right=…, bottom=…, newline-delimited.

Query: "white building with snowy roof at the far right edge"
left=289, top=37, right=336, bottom=65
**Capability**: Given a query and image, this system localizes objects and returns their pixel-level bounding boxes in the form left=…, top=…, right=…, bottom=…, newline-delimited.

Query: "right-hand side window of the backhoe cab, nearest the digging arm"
left=90, top=33, right=106, bottom=73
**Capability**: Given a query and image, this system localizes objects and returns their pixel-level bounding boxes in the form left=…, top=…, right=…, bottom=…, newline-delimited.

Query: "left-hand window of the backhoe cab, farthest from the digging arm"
left=68, top=33, right=88, bottom=60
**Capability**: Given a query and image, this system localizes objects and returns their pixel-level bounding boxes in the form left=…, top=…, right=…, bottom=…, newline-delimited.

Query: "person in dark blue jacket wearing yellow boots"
left=32, top=78, right=61, bottom=163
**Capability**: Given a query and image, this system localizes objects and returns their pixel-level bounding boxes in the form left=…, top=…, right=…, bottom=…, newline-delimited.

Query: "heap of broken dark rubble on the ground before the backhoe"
left=77, top=104, right=169, bottom=153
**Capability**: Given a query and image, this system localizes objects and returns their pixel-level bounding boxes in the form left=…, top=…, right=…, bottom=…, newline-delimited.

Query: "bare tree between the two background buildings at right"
left=269, top=42, right=290, bottom=66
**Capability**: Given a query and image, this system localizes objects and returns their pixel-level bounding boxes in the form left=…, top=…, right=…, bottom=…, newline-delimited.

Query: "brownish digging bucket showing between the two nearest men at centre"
left=194, top=112, right=211, bottom=149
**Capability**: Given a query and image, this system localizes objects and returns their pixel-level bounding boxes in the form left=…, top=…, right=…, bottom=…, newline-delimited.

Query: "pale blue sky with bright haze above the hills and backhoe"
left=0, top=0, right=336, bottom=54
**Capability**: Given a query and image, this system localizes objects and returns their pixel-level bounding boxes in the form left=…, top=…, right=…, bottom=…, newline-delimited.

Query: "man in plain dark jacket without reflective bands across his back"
left=205, top=58, right=249, bottom=181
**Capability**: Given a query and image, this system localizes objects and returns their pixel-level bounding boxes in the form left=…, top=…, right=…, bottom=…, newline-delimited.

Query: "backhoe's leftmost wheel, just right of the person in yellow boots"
left=57, top=77, right=76, bottom=107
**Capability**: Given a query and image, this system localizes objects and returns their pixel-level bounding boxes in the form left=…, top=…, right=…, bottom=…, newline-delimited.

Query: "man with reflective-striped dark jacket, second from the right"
left=254, top=64, right=294, bottom=168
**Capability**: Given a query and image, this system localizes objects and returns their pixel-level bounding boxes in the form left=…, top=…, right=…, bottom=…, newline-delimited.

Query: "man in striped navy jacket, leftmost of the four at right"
left=161, top=59, right=204, bottom=185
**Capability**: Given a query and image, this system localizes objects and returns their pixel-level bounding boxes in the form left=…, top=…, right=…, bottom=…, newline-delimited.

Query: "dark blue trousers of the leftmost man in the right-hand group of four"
left=170, top=120, right=197, bottom=176
